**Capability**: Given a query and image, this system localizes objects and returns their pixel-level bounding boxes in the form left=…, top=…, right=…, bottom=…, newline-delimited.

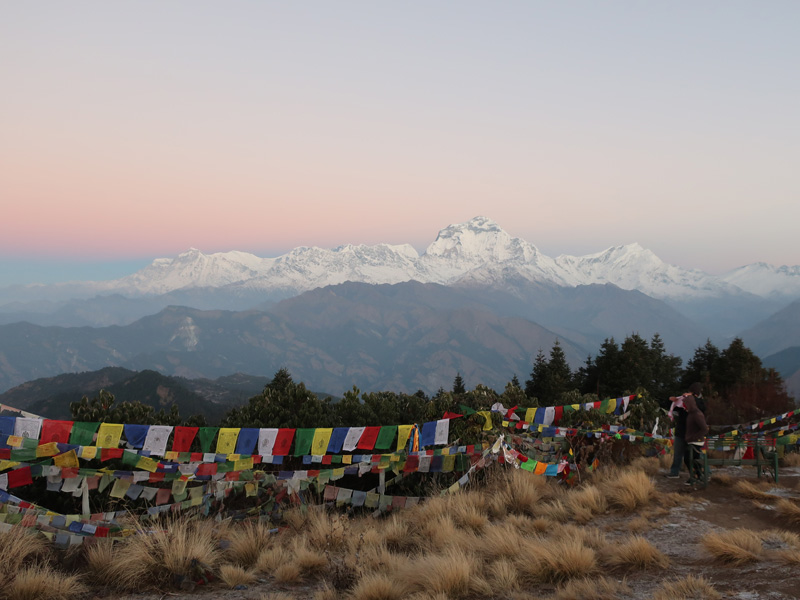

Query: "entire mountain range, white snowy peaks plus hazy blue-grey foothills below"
left=0, top=217, right=800, bottom=394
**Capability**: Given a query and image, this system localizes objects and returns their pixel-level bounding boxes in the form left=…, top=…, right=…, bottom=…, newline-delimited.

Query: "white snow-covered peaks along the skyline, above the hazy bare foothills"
left=0, top=217, right=800, bottom=301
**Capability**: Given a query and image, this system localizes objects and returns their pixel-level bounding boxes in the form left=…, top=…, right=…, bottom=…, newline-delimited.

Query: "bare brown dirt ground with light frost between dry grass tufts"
left=93, top=467, right=800, bottom=600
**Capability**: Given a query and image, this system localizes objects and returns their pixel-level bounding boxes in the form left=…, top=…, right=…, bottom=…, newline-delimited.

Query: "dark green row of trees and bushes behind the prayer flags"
left=70, top=334, right=794, bottom=428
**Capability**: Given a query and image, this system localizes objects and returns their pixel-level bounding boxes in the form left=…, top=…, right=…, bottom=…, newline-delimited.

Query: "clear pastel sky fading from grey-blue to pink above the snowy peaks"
left=0, top=0, right=800, bottom=285
